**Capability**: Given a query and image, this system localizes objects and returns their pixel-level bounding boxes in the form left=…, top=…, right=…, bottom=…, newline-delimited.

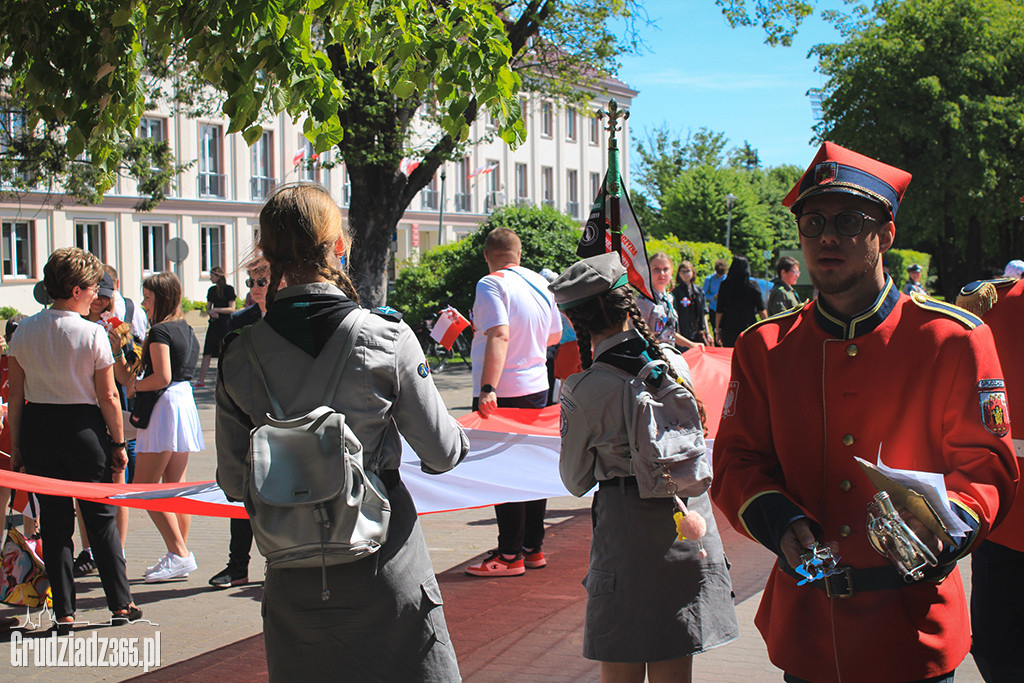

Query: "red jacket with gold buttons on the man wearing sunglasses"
left=712, top=278, right=1018, bottom=683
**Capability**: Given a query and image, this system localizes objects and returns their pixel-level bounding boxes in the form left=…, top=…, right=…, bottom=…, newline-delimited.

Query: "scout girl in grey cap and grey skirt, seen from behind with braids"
left=550, top=253, right=739, bottom=681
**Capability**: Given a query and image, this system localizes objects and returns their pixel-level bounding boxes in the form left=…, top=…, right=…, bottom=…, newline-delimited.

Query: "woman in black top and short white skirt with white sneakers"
left=128, top=272, right=205, bottom=584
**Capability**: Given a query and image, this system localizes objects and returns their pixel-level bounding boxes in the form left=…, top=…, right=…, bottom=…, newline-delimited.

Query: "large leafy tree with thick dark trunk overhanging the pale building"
left=0, top=0, right=831, bottom=303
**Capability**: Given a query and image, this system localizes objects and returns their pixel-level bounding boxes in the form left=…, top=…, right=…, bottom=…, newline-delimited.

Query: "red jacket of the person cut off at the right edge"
left=984, top=280, right=1024, bottom=552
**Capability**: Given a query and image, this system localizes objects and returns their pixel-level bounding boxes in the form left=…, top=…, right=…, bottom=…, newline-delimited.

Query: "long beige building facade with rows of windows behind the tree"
left=0, top=80, right=637, bottom=314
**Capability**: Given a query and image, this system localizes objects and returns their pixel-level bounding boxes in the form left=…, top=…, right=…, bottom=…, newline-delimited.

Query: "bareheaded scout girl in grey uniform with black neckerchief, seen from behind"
left=216, top=184, right=469, bottom=683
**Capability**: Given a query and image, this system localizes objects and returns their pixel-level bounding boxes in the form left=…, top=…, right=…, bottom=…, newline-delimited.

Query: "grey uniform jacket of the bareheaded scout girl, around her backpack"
left=216, top=283, right=469, bottom=500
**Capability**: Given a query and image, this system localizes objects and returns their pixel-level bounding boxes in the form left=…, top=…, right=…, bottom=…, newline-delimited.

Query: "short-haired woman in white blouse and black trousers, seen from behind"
left=9, top=247, right=142, bottom=635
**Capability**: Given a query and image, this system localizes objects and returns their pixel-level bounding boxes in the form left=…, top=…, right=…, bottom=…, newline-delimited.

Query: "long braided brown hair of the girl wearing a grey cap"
left=565, top=285, right=708, bottom=426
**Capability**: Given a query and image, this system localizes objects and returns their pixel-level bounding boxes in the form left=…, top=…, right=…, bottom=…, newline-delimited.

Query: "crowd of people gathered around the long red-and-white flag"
left=4, top=143, right=1024, bottom=683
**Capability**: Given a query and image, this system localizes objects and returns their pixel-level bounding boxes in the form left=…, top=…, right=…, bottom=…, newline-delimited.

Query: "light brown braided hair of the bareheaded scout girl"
left=256, top=182, right=359, bottom=307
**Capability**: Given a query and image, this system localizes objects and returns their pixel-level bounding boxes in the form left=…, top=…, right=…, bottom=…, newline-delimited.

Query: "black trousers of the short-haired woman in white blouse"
left=20, top=403, right=131, bottom=617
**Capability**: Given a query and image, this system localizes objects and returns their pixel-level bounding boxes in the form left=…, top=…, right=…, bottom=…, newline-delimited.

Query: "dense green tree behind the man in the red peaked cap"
left=814, top=0, right=1024, bottom=298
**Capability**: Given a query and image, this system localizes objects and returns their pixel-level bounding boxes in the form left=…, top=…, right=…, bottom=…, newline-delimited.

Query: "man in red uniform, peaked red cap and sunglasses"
left=712, top=142, right=1018, bottom=683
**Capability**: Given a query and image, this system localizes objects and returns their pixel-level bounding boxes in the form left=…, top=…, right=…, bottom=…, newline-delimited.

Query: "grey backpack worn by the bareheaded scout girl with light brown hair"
left=241, top=309, right=391, bottom=600
